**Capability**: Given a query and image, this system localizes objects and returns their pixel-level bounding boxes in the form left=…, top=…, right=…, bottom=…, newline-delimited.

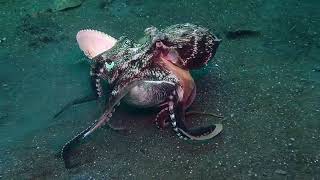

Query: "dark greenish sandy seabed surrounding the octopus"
left=0, top=0, right=320, bottom=180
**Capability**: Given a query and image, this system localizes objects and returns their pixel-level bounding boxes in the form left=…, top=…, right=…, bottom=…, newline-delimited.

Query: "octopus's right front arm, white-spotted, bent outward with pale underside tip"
left=168, top=91, right=222, bottom=140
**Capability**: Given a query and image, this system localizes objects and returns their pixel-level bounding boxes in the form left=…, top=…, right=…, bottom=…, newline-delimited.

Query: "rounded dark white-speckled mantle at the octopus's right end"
left=153, top=23, right=221, bottom=69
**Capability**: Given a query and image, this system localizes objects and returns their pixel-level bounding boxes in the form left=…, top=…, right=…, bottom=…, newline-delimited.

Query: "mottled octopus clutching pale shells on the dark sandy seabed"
left=62, top=23, right=222, bottom=167
